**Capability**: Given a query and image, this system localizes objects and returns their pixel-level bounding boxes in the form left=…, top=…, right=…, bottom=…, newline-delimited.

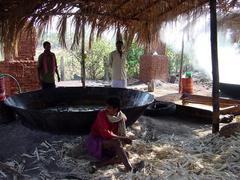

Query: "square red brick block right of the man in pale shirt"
left=139, top=54, right=168, bottom=82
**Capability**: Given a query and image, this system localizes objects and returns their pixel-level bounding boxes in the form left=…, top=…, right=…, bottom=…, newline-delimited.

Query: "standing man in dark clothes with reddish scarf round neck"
left=38, top=41, right=60, bottom=89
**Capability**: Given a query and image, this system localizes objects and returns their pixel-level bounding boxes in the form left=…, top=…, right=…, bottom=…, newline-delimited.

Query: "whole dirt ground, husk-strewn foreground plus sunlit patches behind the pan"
left=0, top=82, right=240, bottom=180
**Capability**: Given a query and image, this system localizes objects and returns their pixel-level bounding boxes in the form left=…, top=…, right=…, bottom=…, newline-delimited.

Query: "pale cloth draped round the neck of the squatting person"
left=107, top=111, right=127, bottom=136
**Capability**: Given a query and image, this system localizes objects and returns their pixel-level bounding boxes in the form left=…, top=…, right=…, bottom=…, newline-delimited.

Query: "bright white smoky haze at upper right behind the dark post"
left=161, top=16, right=240, bottom=84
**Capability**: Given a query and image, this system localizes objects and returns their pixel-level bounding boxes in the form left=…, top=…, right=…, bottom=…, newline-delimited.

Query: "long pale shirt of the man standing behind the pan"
left=109, top=50, right=127, bottom=81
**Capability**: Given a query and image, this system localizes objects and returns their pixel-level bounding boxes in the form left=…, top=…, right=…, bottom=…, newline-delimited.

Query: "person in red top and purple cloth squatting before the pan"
left=86, top=97, right=143, bottom=173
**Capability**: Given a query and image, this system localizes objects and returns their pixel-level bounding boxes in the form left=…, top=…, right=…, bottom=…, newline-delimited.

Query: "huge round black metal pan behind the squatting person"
left=5, top=87, right=154, bottom=134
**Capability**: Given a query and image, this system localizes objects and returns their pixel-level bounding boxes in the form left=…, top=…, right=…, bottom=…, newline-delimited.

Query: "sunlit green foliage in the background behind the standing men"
left=36, top=33, right=192, bottom=80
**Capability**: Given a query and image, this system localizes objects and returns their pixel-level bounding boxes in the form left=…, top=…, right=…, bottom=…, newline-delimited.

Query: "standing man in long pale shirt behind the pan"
left=109, top=30, right=127, bottom=88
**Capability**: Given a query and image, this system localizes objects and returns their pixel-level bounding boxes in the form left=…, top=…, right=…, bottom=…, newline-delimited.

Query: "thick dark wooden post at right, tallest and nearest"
left=209, top=0, right=219, bottom=133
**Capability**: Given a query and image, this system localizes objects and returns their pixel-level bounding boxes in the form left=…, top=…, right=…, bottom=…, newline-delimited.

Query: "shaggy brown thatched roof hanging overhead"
left=0, top=0, right=237, bottom=54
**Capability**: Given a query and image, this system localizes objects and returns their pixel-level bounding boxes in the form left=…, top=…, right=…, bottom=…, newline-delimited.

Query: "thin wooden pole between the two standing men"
left=81, top=20, right=86, bottom=87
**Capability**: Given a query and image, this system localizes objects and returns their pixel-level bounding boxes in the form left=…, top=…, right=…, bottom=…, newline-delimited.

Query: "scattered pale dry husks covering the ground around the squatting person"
left=0, top=116, right=240, bottom=179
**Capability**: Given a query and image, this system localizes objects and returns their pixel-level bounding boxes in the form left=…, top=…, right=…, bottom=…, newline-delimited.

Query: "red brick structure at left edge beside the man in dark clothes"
left=0, top=28, right=40, bottom=96
